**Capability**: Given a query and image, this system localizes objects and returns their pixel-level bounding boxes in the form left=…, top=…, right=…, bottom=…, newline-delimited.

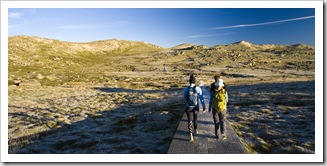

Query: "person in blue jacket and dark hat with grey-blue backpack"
left=184, top=74, right=207, bottom=142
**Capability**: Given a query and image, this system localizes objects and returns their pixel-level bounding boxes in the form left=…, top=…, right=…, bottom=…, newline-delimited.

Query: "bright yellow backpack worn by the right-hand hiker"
left=212, top=87, right=227, bottom=112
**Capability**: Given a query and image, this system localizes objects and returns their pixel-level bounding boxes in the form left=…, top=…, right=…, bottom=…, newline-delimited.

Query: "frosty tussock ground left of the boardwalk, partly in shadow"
left=9, top=85, right=183, bottom=154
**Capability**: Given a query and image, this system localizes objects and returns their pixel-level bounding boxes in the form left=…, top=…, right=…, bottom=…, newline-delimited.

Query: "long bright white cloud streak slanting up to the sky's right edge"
left=210, top=16, right=315, bottom=30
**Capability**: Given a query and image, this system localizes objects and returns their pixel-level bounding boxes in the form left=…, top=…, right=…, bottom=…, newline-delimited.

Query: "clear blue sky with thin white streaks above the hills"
left=8, top=8, right=315, bottom=48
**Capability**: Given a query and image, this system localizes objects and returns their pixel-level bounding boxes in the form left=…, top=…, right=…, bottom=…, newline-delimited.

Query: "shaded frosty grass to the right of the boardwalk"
left=229, top=81, right=315, bottom=154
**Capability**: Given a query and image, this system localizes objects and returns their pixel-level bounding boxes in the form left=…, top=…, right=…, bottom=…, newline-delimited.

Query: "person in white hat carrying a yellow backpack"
left=209, top=78, right=228, bottom=140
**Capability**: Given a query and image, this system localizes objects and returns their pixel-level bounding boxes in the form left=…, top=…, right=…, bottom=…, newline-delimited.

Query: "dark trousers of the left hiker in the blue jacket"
left=185, top=106, right=199, bottom=133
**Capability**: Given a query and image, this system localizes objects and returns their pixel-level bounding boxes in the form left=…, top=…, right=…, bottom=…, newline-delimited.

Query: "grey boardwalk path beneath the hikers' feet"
left=167, top=83, right=248, bottom=154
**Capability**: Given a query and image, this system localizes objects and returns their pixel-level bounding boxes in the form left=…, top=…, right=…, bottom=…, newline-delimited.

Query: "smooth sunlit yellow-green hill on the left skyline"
left=8, top=36, right=163, bottom=70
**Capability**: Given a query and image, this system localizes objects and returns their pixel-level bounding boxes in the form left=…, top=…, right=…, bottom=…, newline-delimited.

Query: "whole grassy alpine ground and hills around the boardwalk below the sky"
left=8, top=36, right=315, bottom=153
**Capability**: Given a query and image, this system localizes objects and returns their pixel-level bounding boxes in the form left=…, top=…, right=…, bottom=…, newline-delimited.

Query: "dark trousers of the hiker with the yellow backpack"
left=212, top=108, right=227, bottom=135
